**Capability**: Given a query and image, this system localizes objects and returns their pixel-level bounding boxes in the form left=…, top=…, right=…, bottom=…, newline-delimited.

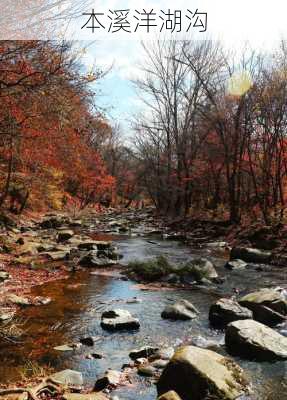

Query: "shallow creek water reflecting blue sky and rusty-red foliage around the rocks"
left=0, top=236, right=287, bottom=400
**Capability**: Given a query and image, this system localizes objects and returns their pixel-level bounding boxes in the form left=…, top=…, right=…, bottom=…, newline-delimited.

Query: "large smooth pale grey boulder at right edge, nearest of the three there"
left=225, top=319, right=287, bottom=361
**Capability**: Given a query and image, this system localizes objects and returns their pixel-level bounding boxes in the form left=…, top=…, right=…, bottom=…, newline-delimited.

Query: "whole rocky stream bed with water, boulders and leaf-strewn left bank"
left=0, top=210, right=287, bottom=400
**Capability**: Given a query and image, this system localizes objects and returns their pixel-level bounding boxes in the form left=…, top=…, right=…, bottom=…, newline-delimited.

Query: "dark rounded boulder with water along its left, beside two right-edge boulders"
left=209, top=299, right=253, bottom=328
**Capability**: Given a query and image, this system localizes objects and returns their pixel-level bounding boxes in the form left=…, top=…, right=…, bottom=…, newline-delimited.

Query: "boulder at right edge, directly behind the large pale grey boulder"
left=239, top=289, right=287, bottom=326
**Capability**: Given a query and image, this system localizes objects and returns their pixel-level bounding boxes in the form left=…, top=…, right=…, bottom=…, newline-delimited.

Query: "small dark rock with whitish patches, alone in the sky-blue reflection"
left=101, top=309, right=140, bottom=331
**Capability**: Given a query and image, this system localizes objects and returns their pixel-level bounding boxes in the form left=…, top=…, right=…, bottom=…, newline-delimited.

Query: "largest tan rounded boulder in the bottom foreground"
left=157, top=346, right=247, bottom=400
